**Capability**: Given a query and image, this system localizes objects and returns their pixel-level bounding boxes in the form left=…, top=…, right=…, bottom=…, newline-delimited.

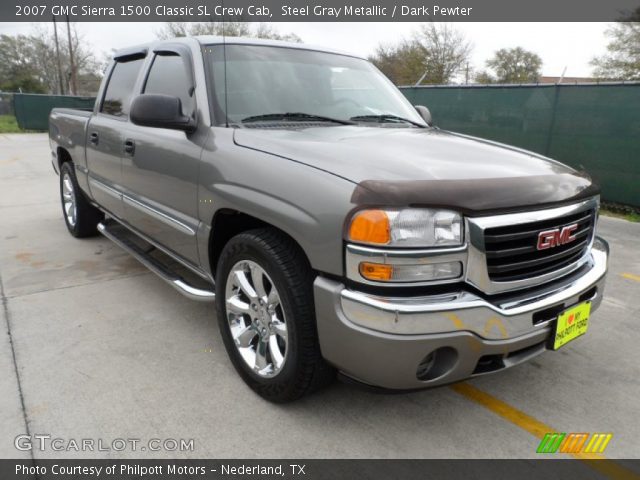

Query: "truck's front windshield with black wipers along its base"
left=203, top=45, right=425, bottom=127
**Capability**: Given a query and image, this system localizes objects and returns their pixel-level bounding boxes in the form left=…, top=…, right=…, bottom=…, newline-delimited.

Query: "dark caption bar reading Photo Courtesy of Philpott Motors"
left=0, top=460, right=640, bottom=480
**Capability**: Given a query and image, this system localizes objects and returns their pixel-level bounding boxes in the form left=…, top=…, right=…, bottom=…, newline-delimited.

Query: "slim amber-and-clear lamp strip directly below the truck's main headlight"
left=359, top=262, right=462, bottom=282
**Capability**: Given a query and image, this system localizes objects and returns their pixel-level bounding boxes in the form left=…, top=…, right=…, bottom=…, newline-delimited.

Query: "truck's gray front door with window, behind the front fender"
left=117, top=47, right=202, bottom=264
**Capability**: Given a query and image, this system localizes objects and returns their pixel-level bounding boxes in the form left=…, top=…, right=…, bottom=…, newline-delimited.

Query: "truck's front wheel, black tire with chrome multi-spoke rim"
left=216, top=229, right=334, bottom=403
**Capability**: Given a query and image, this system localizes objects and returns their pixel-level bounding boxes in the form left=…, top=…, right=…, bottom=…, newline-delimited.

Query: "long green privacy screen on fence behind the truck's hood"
left=401, top=83, right=640, bottom=206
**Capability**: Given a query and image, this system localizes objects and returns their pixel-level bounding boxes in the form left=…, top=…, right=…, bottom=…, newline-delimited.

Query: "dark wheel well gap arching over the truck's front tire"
left=209, top=209, right=309, bottom=276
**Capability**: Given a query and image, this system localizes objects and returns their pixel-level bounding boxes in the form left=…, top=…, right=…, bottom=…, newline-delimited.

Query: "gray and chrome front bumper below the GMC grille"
left=314, top=238, right=609, bottom=389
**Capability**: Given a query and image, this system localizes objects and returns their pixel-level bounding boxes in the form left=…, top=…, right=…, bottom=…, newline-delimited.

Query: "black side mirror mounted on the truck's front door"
left=129, top=93, right=196, bottom=132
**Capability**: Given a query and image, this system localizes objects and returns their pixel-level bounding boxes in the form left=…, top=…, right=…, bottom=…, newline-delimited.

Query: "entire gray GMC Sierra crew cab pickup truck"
left=50, top=37, right=608, bottom=402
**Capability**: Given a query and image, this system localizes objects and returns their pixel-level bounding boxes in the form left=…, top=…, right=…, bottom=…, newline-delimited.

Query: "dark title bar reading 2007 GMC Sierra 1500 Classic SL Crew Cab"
left=0, top=0, right=640, bottom=22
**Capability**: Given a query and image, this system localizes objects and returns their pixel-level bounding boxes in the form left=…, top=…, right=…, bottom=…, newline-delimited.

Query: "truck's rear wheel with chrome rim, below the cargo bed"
left=60, top=162, right=104, bottom=238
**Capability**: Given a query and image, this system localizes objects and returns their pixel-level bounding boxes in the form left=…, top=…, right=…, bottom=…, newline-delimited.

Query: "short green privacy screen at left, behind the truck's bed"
left=13, top=93, right=95, bottom=131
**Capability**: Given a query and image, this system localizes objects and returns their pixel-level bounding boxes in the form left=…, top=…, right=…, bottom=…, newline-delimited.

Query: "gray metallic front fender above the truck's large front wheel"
left=198, top=128, right=355, bottom=275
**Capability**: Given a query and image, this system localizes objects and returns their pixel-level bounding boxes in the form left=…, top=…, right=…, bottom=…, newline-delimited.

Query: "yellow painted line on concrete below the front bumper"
left=450, top=383, right=640, bottom=480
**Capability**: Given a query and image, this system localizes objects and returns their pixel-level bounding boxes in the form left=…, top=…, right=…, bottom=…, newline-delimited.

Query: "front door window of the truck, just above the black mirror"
left=144, top=54, right=195, bottom=116
